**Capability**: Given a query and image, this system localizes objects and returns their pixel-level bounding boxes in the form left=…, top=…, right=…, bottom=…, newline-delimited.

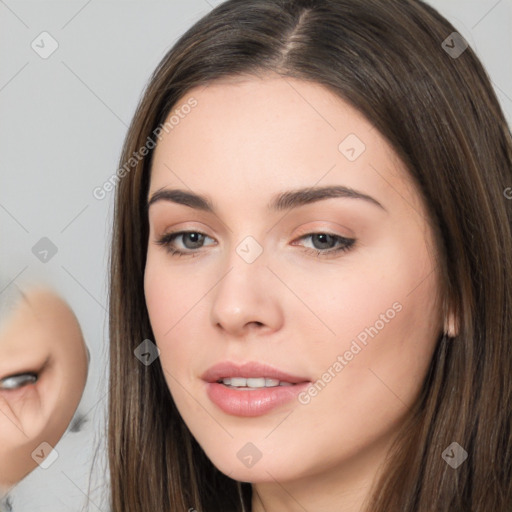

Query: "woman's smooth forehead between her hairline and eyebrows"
left=150, top=76, right=417, bottom=218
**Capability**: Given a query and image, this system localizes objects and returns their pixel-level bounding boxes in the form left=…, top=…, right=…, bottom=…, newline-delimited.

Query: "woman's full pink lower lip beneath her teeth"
left=206, top=382, right=310, bottom=417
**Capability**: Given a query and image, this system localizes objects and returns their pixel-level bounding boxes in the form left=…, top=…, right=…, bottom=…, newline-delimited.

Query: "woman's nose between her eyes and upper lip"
left=211, top=246, right=283, bottom=337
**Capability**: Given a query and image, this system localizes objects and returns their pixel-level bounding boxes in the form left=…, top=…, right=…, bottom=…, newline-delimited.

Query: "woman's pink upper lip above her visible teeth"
left=201, top=361, right=309, bottom=384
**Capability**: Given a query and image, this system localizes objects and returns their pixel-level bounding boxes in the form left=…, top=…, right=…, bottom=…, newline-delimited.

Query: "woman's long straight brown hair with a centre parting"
left=108, top=0, right=512, bottom=512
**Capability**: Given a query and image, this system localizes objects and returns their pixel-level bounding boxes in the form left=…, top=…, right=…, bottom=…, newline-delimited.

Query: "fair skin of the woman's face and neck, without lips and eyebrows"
left=145, top=76, right=452, bottom=512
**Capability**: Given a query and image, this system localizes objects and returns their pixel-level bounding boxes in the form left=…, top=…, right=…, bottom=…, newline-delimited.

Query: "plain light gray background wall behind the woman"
left=0, top=0, right=512, bottom=512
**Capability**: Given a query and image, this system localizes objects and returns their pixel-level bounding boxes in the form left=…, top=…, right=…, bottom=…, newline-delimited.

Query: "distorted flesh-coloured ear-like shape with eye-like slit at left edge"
left=0, top=289, right=88, bottom=492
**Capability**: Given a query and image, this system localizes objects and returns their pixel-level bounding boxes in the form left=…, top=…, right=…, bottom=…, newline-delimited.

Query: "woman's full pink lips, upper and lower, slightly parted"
left=201, top=361, right=311, bottom=417
